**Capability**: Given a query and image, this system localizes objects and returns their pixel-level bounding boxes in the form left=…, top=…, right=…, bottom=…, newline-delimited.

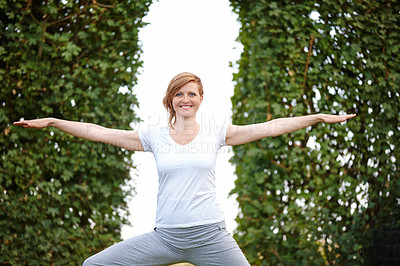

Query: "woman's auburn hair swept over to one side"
left=163, top=72, right=203, bottom=128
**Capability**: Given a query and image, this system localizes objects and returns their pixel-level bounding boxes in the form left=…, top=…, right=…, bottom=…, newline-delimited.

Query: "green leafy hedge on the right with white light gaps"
left=231, top=0, right=400, bottom=265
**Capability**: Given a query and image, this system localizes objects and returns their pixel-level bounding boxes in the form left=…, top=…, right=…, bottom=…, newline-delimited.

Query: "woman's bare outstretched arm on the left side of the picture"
left=14, top=118, right=143, bottom=151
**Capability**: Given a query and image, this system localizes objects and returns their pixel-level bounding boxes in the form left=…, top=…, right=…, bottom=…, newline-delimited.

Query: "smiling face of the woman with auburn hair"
left=172, top=82, right=203, bottom=117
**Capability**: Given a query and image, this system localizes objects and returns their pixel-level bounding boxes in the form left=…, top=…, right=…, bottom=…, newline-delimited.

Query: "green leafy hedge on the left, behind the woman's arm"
left=0, top=0, right=151, bottom=265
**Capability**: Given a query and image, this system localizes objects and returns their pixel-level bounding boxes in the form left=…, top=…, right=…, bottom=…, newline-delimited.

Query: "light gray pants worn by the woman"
left=83, top=222, right=250, bottom=266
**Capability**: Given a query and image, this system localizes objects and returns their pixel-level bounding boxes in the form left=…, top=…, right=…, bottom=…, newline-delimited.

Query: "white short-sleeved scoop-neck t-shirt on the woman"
left=139, top=123, right=227, bottom=228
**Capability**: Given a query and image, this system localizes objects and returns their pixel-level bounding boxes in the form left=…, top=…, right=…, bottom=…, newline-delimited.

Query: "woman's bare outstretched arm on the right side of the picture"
left=226, top=114, right=356, bottom=145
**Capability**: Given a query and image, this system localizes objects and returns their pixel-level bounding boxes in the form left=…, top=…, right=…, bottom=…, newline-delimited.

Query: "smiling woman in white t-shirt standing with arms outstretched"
left=14, top=72, right=355, bottom=266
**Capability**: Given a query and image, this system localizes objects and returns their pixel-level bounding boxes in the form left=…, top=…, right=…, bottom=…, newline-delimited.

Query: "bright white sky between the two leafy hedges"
left=122, top=0, right=242, bottom=239
